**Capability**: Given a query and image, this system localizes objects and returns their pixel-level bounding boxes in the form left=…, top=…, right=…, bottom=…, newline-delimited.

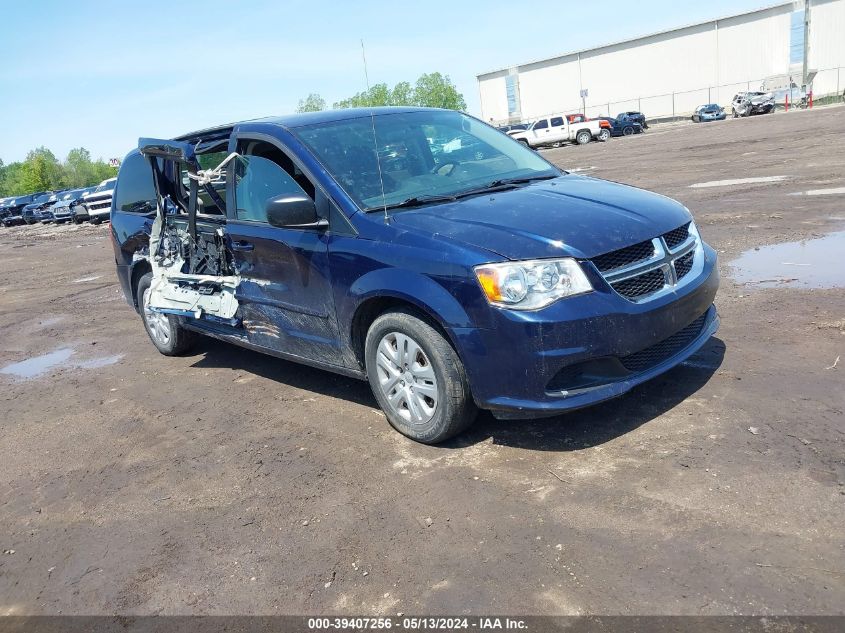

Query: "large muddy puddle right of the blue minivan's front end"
left=730, top=231, right=845, bottom=288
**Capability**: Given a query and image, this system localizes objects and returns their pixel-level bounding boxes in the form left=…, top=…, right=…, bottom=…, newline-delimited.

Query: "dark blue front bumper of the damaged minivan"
left=451, top=246, right=719, bottom=418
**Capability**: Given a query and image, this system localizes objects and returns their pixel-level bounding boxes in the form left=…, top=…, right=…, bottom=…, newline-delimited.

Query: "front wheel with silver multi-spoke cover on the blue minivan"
left=364, top=310, right=478, bottom=444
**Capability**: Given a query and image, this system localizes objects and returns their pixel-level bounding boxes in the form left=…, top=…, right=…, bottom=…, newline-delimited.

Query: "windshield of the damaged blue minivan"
left=295, top=110, right=560, bottom=211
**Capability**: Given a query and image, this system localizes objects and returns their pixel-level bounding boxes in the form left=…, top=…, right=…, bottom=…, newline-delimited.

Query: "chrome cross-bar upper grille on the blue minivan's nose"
left=590, top=222, right=697, bottom=302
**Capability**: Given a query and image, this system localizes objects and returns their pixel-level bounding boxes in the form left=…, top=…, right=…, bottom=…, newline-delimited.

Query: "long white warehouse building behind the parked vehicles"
left=478, top=0, right=845, bottom=124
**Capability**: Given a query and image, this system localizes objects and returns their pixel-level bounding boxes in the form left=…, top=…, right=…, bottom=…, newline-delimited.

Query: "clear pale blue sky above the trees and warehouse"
left=0, top=0, right=768, bottom=163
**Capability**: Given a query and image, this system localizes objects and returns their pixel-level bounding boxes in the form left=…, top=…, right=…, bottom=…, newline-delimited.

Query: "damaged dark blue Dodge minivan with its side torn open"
left=111, top=108, right=719, bottom=443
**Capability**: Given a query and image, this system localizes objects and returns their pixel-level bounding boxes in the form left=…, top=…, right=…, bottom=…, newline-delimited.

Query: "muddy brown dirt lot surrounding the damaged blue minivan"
left=0, top=107, right=845, bottom=614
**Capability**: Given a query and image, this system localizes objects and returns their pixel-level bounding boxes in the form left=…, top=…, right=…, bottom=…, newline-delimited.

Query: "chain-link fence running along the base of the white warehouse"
left=496, top=66, right=845, bottom=125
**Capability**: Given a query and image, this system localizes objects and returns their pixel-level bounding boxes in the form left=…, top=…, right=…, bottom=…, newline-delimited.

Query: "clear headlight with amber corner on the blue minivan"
left=474, top=258, right=593, bottom=310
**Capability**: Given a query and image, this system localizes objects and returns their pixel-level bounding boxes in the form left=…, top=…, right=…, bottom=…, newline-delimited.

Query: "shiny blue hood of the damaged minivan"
left=393, top=174, right=690, bottom=259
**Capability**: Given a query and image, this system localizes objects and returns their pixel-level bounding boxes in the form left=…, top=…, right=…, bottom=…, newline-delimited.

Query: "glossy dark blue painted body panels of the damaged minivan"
left=112, top=109, right=718, bottom=417
